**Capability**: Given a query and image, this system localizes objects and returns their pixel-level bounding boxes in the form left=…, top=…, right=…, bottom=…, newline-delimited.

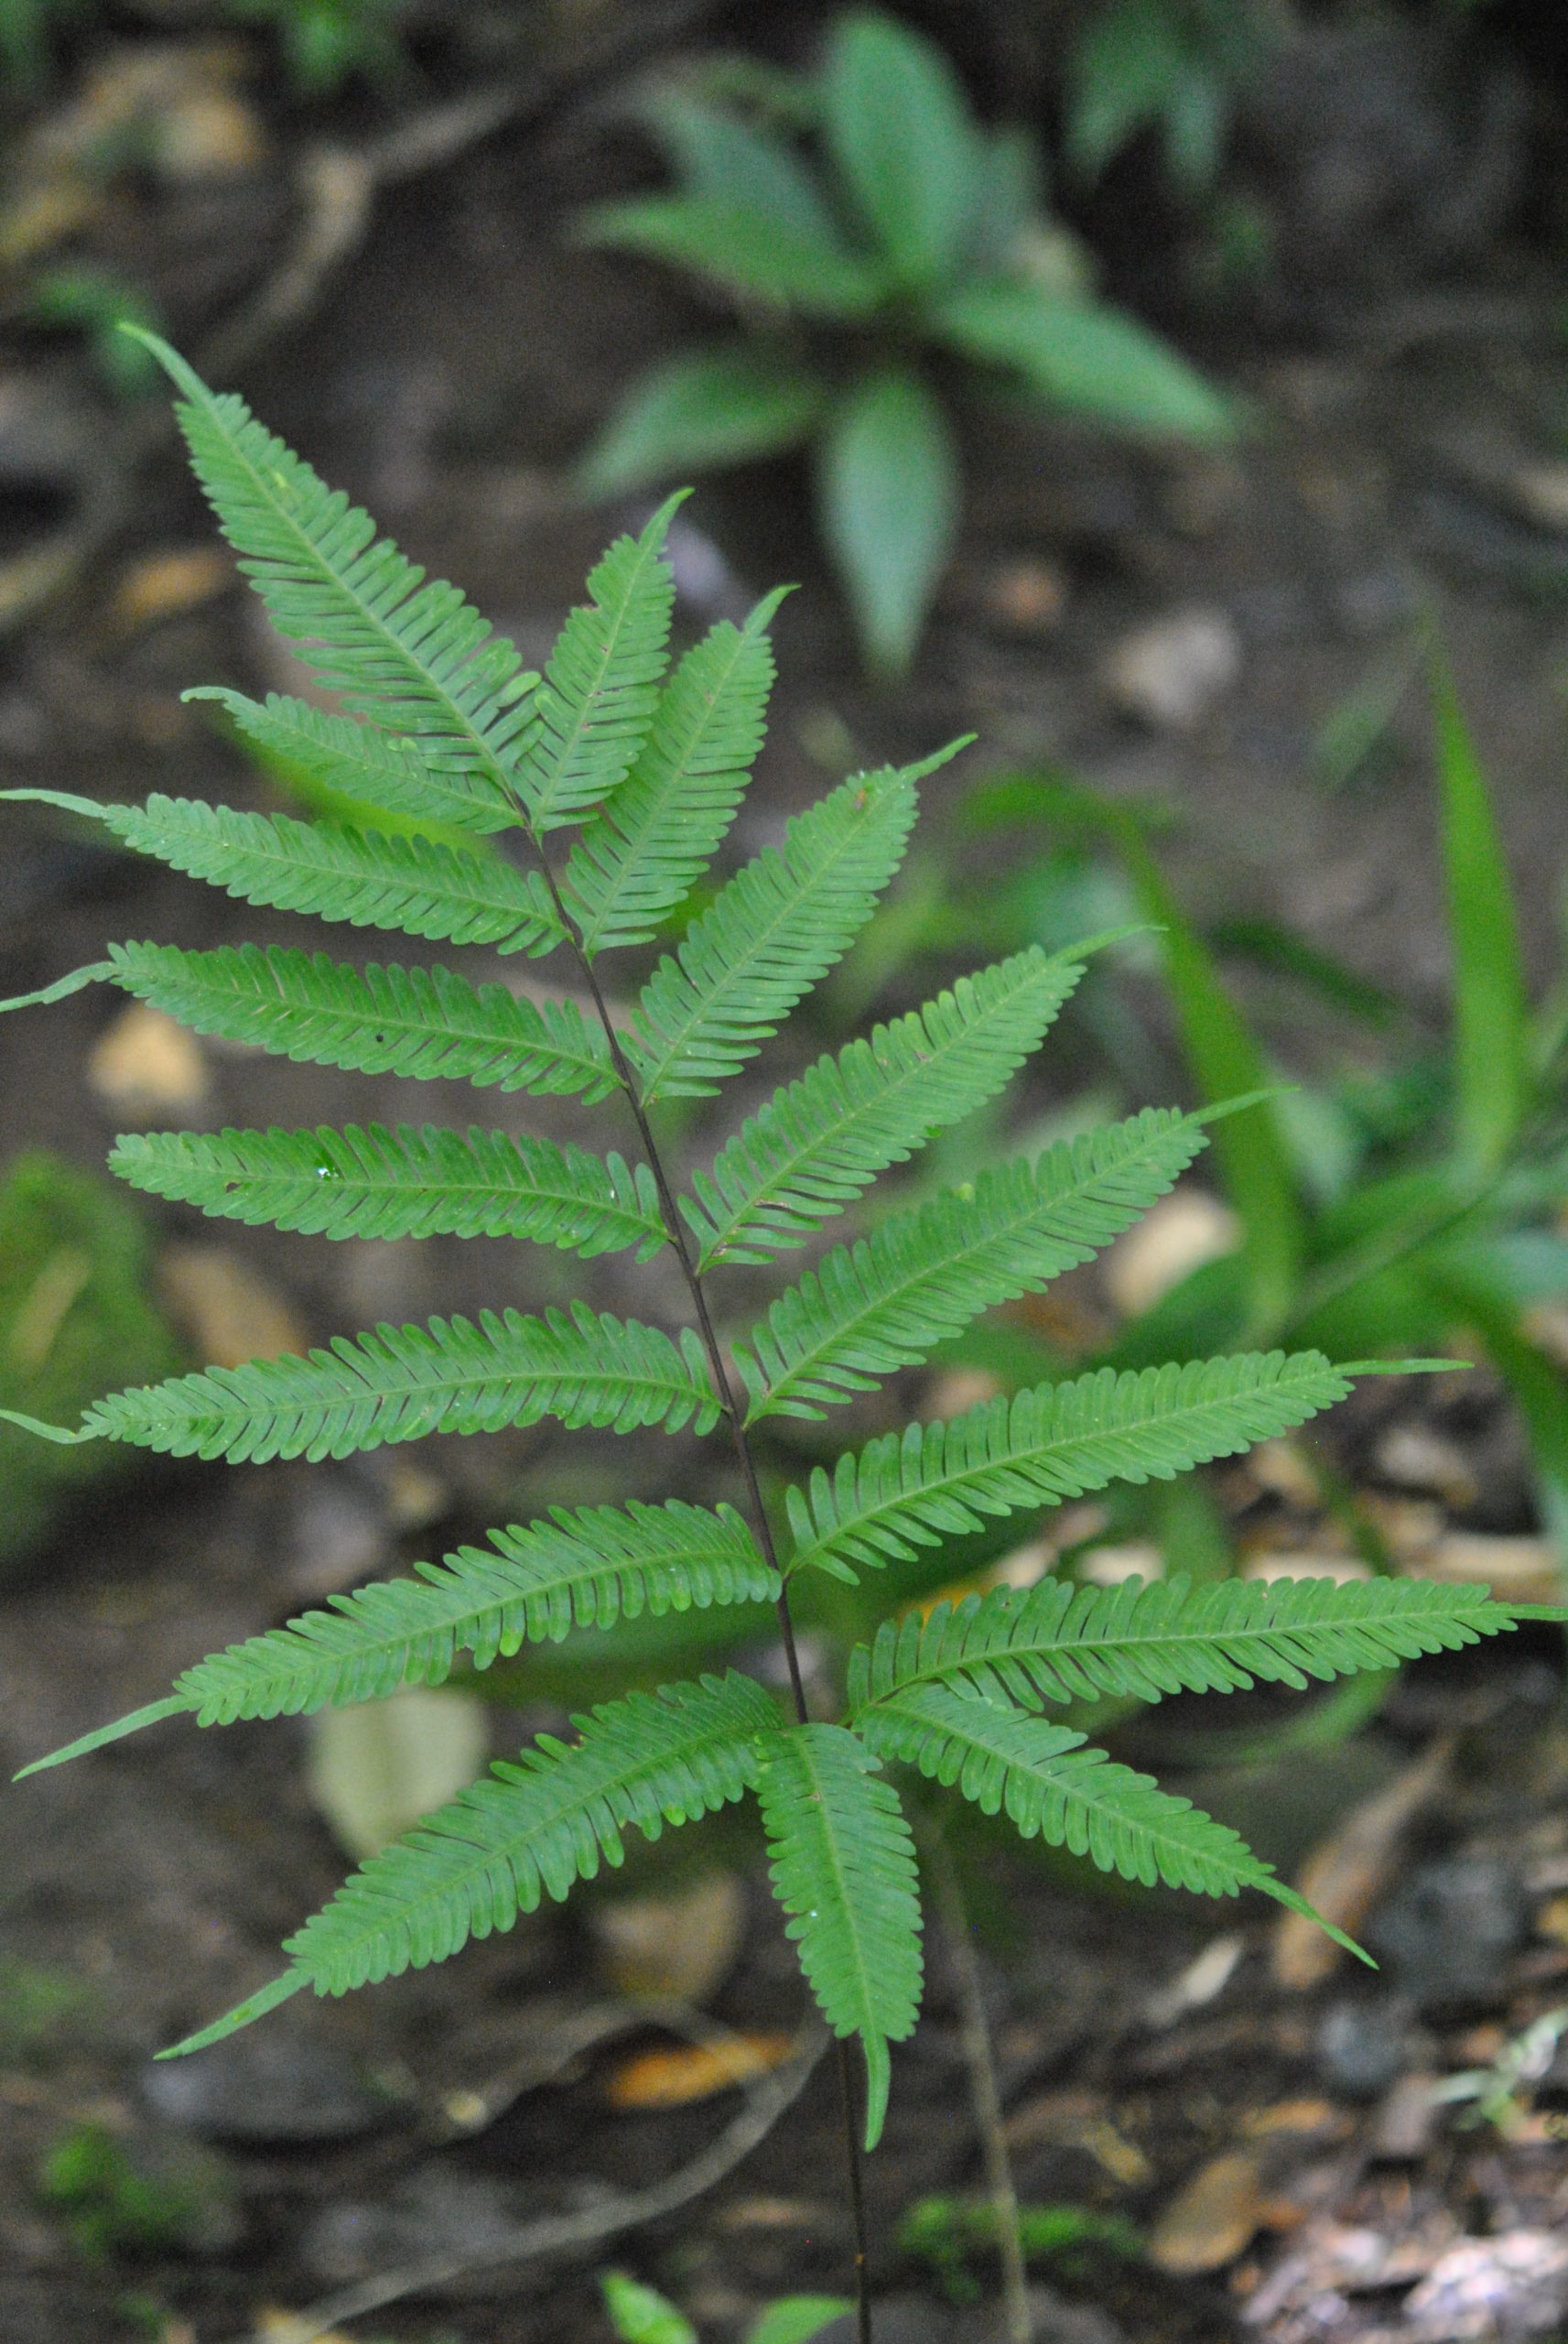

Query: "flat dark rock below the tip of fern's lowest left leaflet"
left=141, top=2025, right=389, bottom=2147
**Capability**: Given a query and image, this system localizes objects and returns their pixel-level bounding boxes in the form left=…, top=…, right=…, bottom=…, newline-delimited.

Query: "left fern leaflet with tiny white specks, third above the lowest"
left=110, top=1123, right=668, bottom=1261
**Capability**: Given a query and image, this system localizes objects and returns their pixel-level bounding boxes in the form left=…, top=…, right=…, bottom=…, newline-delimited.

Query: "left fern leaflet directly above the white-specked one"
left=95, top=945, right=619, bottom=1104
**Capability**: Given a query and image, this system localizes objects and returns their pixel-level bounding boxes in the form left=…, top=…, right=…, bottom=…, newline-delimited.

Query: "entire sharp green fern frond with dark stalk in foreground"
left=7, top=338, right=1556, bottom=2337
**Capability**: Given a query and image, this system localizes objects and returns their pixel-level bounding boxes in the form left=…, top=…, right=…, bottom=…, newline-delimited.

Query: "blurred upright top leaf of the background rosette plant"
left=820, top=9, right=984, bottom=286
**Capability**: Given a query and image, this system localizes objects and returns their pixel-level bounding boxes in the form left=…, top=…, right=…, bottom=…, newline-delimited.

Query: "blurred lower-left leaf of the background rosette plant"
left=577, top=342, right=827, bottom=497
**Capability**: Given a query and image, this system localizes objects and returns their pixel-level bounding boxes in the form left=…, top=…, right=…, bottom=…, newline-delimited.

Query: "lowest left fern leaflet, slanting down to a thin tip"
left=176, top=1671, right=778, bottom=2051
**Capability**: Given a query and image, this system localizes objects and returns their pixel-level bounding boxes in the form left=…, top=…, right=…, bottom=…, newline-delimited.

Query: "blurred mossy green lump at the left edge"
left=0, top=1148, right=178, bottom=1570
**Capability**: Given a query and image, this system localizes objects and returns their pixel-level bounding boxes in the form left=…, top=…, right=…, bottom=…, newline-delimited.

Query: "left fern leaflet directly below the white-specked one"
left=64, top=1303, right=719, bottom=1465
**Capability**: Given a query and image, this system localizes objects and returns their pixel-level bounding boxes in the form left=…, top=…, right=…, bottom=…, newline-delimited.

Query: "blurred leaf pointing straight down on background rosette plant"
left=818, top=368, right=961, bottom=678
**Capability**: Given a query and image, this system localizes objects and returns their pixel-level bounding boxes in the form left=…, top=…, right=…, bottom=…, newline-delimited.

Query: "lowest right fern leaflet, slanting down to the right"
left=860, top=1686, right=1376, bottom=1967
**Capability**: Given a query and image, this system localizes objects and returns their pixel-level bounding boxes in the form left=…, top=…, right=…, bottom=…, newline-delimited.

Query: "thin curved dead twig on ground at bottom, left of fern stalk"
left=227, top=2009, right=827, bottom=2344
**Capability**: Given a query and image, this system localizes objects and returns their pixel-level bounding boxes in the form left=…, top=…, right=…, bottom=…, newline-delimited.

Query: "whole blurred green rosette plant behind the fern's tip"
left=577, top=9, right=1233, bottom=678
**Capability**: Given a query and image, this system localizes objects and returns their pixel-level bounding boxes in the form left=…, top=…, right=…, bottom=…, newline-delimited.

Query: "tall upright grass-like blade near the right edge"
left=1430, top=647, right=1530, bottom=1172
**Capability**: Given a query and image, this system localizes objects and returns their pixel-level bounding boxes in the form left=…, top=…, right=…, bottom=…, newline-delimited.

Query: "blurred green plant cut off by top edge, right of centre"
left=1064, top=0, right=1277, bottom=197
